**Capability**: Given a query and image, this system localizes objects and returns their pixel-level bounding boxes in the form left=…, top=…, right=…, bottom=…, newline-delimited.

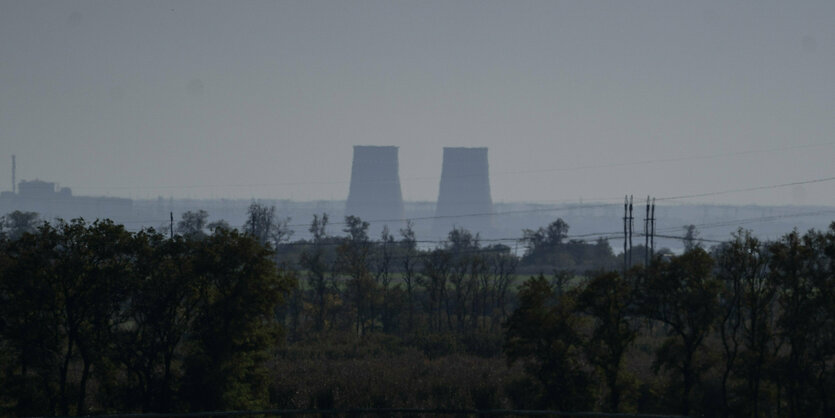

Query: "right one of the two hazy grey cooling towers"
left=433, top=147, right=493, bottom=235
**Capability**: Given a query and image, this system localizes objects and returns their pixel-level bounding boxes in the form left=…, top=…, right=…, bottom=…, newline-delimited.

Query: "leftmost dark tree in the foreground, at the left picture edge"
left=0, top=219, right=131, bottom=415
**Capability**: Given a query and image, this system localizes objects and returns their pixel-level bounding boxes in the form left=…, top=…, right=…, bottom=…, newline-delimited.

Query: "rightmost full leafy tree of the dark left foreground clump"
left=184, top=230, right=294, bottom=410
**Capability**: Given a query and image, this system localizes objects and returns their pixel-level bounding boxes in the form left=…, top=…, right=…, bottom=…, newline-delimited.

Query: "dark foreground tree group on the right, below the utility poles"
left=505, top=224, right=835, bottom=417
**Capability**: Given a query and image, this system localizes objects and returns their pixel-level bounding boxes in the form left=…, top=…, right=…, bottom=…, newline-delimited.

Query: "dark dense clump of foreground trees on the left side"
left=0, top=214, right=295, bottom=416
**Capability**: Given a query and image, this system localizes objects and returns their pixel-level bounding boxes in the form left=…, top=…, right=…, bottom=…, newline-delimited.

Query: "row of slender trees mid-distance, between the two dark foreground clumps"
left=279, top=214, right=518, bottom=339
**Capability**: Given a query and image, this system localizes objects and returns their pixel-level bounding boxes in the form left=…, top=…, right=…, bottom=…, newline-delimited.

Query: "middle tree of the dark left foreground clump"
left=114, top=230, right=205, bottom=412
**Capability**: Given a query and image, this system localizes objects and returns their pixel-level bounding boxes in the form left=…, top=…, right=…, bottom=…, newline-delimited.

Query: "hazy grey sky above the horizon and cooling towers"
left=0, top=0, right=835, bottom=204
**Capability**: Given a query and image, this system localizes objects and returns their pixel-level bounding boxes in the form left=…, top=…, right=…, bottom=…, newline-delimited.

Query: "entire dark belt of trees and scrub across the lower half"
left=0, top=204, right=835, bottom=417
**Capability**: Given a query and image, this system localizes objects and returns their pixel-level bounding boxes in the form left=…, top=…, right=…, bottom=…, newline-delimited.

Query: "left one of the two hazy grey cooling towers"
left=345, top=145, right=403, bottom=230
